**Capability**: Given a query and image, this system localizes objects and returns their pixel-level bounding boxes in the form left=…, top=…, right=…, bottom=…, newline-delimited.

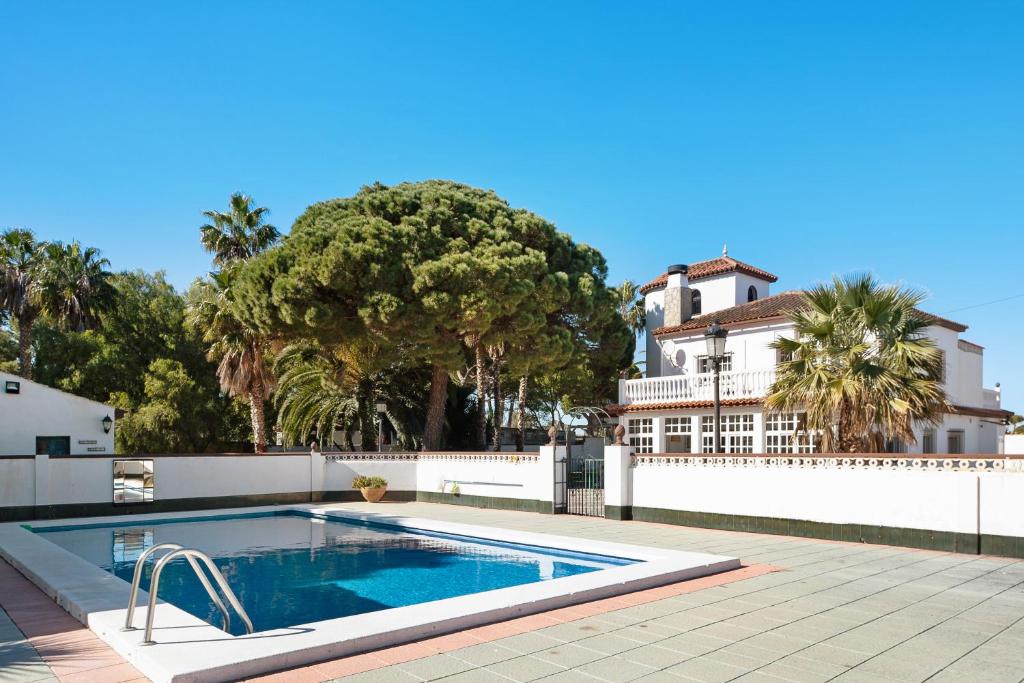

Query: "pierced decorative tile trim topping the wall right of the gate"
left=631, top=454, right=1024, bottom=472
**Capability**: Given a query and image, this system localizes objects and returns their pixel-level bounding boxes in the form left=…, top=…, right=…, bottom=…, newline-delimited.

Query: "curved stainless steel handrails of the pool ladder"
left=122, top=543, right=253, bottom=645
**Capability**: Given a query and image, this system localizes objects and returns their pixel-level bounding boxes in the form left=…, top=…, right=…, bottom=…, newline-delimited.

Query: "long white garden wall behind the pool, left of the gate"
left=0, top=447, right=553, bottom=521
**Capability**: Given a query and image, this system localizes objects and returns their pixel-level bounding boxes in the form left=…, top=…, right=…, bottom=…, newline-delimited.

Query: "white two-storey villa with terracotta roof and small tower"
left=611, top=250, right=1010, bottom=454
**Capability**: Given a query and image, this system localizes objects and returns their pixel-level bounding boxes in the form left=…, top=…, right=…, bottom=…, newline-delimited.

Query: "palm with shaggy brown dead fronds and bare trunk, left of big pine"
left=186, top=268, right=274, bottom=453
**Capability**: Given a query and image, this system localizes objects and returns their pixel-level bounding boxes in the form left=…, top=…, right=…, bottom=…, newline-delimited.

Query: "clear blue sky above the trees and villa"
left=0, top=0, right=1024, bottom=411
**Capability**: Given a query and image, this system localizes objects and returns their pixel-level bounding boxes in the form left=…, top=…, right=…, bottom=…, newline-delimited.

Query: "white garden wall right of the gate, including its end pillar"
left=605, top=446, right=1024, bottom=556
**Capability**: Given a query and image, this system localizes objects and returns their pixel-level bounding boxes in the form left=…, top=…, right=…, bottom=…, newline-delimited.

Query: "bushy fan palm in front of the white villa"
left=765, top=275, right=949, bottom=453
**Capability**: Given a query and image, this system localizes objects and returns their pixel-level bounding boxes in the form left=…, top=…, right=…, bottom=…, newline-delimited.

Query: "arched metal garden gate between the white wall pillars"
left=554, top=408, right=608, bottom=517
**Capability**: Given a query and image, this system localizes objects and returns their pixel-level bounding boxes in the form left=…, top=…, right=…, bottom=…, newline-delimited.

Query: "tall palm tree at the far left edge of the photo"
left=0, top=228, right=43, bottom=379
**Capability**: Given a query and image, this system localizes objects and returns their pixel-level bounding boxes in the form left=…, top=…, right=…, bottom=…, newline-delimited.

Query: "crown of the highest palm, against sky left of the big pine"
left=199, top=193, right=281, bottom=266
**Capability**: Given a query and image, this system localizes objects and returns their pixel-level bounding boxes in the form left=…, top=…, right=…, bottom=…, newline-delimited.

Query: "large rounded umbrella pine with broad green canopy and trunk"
left=237, top=180, right=573, bottom=449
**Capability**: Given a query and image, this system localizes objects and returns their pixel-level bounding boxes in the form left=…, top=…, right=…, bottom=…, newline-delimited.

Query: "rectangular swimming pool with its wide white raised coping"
left=0, top=504, right=739, bottom=683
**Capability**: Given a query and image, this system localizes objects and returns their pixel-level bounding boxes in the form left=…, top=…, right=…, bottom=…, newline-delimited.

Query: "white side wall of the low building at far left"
left=0, top=373, right=114, bottom=456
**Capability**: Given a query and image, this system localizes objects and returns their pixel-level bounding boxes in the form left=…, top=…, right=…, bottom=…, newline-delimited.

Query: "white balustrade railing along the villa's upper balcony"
left=618, top=368, right=775, bottom=405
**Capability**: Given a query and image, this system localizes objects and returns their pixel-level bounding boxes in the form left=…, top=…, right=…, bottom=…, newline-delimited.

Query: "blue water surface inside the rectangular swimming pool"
left=34, top=510, right=633, bottom=633
